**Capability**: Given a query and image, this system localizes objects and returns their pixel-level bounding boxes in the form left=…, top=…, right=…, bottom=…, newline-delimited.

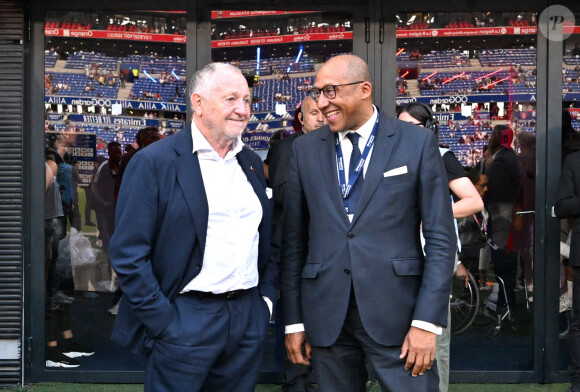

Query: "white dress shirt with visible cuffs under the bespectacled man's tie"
left=285, top=105, right=443, bottom=335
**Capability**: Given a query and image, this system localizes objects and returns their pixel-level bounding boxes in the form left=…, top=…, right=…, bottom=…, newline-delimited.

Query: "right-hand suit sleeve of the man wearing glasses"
left=413, top=133, right=457, bottom=327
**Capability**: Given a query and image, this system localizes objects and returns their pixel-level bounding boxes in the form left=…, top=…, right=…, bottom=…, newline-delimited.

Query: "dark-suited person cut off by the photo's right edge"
left=554, top=151, right=580, bottom=392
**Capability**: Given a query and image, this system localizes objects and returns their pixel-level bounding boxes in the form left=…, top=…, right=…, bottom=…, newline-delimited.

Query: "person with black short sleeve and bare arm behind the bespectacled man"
left=397, top=102, right=483, bottom=392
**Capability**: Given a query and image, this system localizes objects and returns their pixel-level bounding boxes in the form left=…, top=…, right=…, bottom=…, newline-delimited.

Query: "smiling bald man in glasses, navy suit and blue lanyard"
left=281, top=55, right=456, bottom=392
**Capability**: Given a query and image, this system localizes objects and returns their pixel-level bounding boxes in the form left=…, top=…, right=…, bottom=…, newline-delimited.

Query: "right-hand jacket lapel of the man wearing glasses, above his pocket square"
left=351, top=116, right=396, bottom=225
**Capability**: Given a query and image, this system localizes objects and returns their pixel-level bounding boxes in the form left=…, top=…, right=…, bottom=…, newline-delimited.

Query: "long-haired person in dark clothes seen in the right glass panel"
left=482, top=125, right=522, bottom=305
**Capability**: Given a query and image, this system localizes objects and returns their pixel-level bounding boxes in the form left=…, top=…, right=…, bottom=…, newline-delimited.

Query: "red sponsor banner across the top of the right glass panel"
left=396, top=26, right=538, bottom=38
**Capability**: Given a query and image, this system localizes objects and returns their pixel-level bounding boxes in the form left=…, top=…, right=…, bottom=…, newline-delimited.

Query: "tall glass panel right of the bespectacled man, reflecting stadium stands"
left=396, top=12, right=537, bottom=370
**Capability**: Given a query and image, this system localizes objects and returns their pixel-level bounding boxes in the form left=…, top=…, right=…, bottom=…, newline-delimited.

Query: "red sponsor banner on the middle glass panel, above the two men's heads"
left=211, top=31, right=352, bottom=49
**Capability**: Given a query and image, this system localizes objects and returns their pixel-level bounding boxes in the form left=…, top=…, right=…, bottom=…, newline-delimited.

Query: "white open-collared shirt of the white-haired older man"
left=182, top=121, right=262, bottom=294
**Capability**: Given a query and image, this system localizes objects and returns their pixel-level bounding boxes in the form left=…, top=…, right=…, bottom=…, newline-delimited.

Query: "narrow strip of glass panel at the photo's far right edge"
left=555, top=12, right=580, bottom=370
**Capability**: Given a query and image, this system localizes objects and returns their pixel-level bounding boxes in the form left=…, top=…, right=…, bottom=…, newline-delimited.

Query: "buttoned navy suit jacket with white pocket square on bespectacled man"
left=281, top=116, right=456, bottom=346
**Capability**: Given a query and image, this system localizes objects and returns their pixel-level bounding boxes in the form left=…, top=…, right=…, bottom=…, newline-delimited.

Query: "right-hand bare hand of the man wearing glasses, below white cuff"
left=399, top=327, right=437, bottom=377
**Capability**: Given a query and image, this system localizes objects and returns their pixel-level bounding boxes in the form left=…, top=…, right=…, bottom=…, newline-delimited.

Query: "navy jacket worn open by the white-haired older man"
left=109, top=131, right=277, bottom=353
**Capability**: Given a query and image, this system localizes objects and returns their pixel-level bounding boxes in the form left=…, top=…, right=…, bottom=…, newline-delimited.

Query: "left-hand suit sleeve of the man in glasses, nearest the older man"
left=280, top=143, right=309, bottom=325
